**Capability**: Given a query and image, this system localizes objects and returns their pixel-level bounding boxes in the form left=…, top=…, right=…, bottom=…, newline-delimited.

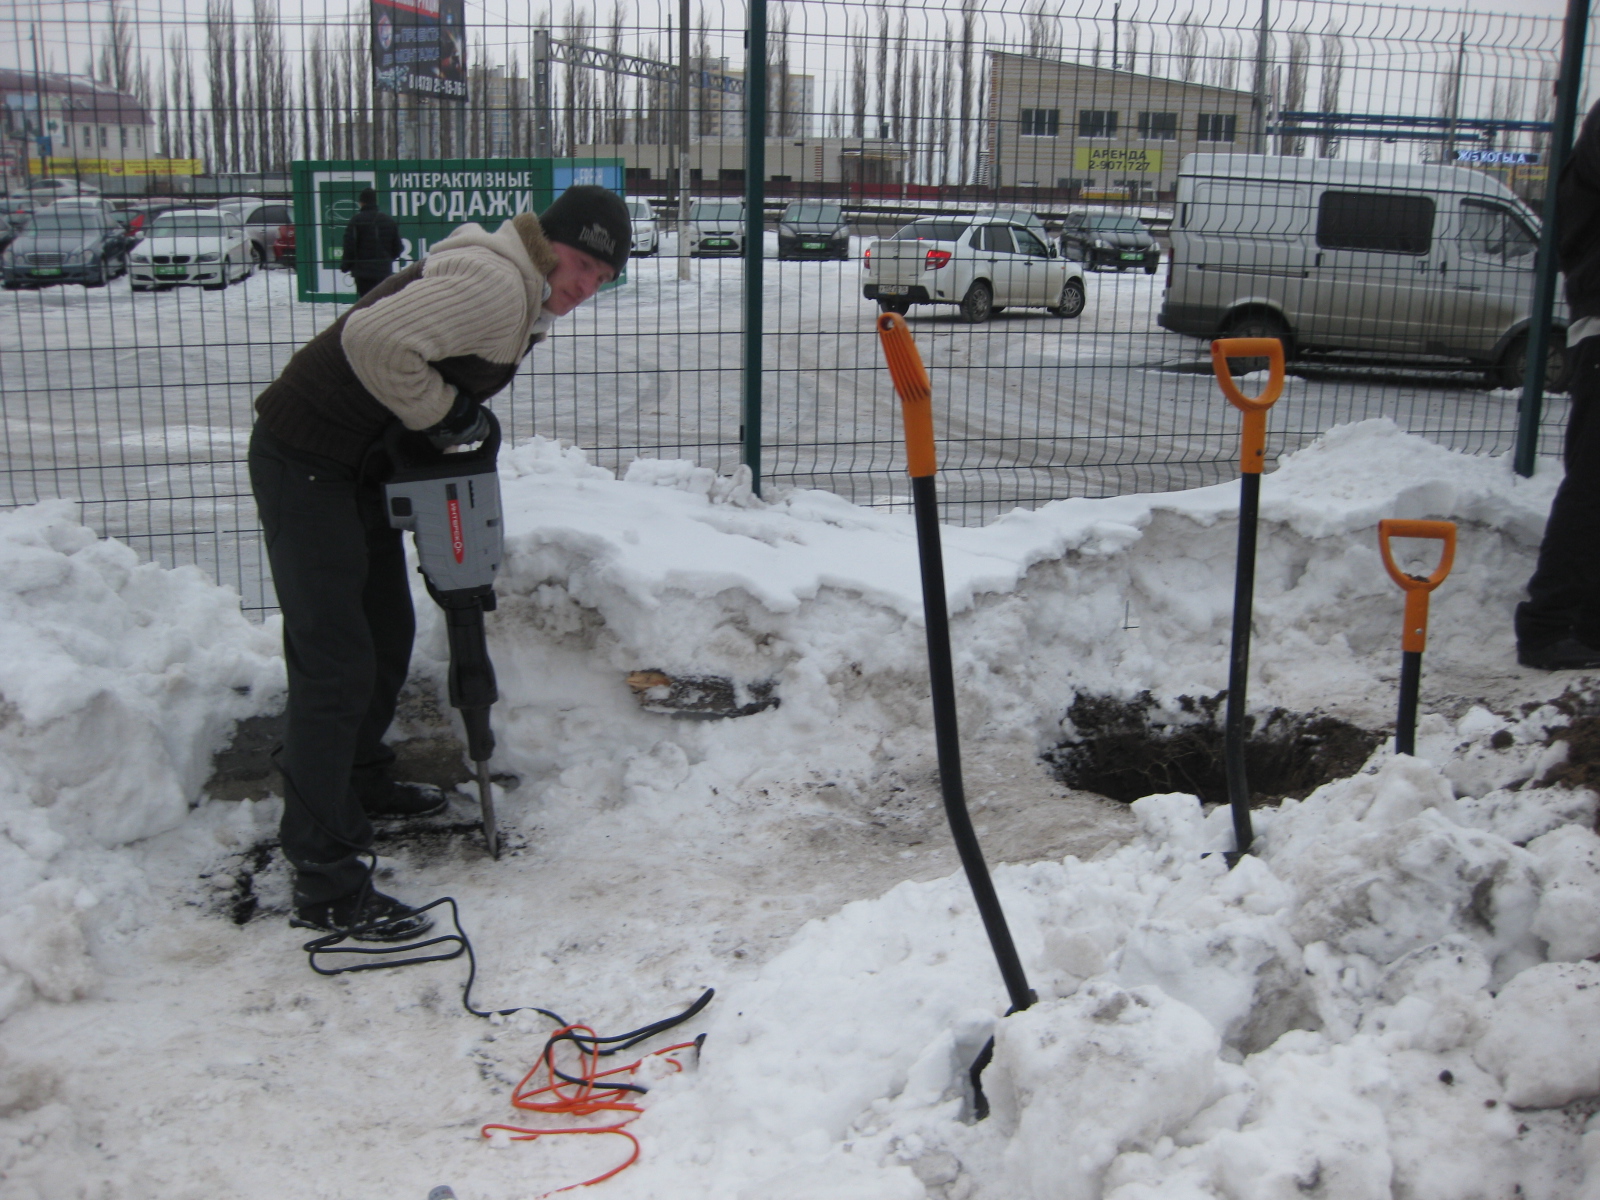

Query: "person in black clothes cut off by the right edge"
left=1515, top=104, right=1600, bottom=670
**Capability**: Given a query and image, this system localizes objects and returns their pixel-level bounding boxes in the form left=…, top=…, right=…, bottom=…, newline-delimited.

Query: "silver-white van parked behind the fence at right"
left=1158, top=154, right=1566, bottom=390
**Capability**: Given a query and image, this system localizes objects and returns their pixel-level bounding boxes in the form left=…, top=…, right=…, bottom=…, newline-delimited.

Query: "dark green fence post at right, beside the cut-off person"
left=1512, top=0, right=1589, bottom=475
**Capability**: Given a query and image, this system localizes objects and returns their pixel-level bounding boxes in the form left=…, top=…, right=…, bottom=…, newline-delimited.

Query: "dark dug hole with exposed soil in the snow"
left=1045, top=693, right=1387, bottom=805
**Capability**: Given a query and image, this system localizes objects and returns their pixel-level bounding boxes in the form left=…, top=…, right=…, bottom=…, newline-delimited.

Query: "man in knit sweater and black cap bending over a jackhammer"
left=250, top=186, right=632, bottom=941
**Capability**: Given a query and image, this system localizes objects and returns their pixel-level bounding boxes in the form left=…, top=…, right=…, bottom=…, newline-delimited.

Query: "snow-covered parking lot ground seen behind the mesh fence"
left=0, top=234, right=1565, bottom=608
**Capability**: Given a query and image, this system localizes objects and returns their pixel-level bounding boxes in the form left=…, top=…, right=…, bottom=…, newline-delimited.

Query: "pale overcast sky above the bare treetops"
left=0, top=0, right=1600, bottom=129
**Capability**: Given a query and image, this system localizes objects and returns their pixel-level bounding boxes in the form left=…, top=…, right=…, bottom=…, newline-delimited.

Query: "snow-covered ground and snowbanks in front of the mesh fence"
left=0, top=421, right=1600, bottom=1200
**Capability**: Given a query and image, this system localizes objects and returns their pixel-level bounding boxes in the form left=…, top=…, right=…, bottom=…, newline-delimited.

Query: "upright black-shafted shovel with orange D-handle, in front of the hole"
left=1211, top=338, right=1283, bottom=859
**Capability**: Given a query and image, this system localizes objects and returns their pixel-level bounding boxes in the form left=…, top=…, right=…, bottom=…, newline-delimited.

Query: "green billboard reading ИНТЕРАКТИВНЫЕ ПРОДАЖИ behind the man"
left=293, top=158, right=626, bottom=304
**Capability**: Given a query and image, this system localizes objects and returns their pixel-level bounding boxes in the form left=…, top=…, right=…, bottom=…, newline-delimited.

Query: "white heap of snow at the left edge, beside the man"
left=0, top=501, right=282, bottom=1018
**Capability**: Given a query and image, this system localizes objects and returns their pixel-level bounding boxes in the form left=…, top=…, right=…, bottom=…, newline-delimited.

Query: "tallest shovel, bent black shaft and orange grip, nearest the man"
left=878, top=312, right=1038, bottom=1117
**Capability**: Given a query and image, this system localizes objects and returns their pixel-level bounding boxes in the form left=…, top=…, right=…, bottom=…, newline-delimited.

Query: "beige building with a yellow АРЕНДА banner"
left=979, top=51, right=1256, bottom=197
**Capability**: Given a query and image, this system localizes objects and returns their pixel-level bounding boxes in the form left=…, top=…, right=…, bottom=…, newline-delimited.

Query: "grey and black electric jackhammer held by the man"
left=384, top=410, right=504, bottom=859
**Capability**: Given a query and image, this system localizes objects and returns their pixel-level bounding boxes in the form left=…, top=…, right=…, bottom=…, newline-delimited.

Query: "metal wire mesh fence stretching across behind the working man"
left=0, top=0, right=1565, bottom=610
